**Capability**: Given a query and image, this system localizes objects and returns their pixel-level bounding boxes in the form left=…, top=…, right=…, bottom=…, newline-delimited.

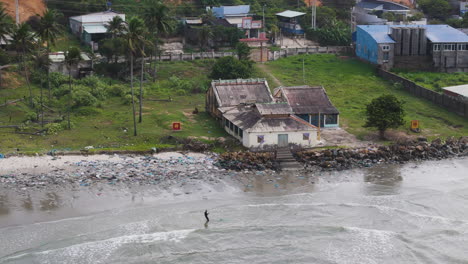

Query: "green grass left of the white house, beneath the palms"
left=0, top=61, right=226, bottom=153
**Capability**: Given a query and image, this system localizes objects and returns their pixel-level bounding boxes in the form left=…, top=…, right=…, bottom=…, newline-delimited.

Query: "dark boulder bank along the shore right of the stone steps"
left=295, top=137, right=468, bottom=170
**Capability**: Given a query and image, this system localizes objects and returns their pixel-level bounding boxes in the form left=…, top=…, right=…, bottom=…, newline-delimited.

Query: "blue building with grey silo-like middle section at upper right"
left=355, top=25, right=468, bottom=72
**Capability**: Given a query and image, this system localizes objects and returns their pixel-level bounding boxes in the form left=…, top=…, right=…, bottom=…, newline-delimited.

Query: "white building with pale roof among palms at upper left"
left=70, top=10, right=125, bottom=50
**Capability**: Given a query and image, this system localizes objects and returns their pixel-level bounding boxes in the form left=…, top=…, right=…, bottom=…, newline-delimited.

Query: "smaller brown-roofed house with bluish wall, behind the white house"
left=273, top=85, right=340, bottom=128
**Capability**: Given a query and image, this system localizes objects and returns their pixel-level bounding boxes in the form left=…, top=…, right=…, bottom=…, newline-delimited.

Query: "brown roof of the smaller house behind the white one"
left=275, top=86, right=339, bottom=115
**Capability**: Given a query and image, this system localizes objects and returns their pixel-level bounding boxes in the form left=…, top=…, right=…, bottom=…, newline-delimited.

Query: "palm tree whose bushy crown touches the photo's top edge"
left=143, top=0, right=174, bottom=81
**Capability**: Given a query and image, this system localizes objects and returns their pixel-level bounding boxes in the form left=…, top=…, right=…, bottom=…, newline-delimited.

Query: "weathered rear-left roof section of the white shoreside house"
left=211, top=79, right=273, bottom=107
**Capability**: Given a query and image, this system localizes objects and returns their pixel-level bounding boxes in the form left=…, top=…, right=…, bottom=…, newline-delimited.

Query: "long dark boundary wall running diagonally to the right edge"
left=378, top=69, right=468, bottom=118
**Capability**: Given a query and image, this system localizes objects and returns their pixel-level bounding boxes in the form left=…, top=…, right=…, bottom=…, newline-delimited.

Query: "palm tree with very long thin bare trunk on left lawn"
left=123, top=17, right=146, bottom=136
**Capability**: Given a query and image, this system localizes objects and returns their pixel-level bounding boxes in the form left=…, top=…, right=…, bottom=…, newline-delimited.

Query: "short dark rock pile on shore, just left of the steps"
left=215, top=152, right=278, bottom=171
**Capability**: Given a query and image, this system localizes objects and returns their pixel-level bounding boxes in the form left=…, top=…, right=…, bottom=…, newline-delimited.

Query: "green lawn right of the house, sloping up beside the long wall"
left=258, top=54, right=468, bottom=139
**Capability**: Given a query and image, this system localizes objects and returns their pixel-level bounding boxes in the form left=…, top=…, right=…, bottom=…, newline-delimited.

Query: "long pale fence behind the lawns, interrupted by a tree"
left=157, top=46, right=352, bottom=61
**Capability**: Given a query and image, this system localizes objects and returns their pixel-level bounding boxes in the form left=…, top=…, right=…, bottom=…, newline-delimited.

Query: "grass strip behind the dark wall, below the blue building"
left=394, top=70, right=468, bottom=93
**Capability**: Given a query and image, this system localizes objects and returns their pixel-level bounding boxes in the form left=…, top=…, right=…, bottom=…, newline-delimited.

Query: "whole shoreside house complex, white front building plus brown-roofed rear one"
left=206, top=79, right=338, bottom=149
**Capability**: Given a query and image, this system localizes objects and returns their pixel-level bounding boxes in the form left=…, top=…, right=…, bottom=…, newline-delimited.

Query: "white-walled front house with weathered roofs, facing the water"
left=206, top=79, right=324, bottom=149
